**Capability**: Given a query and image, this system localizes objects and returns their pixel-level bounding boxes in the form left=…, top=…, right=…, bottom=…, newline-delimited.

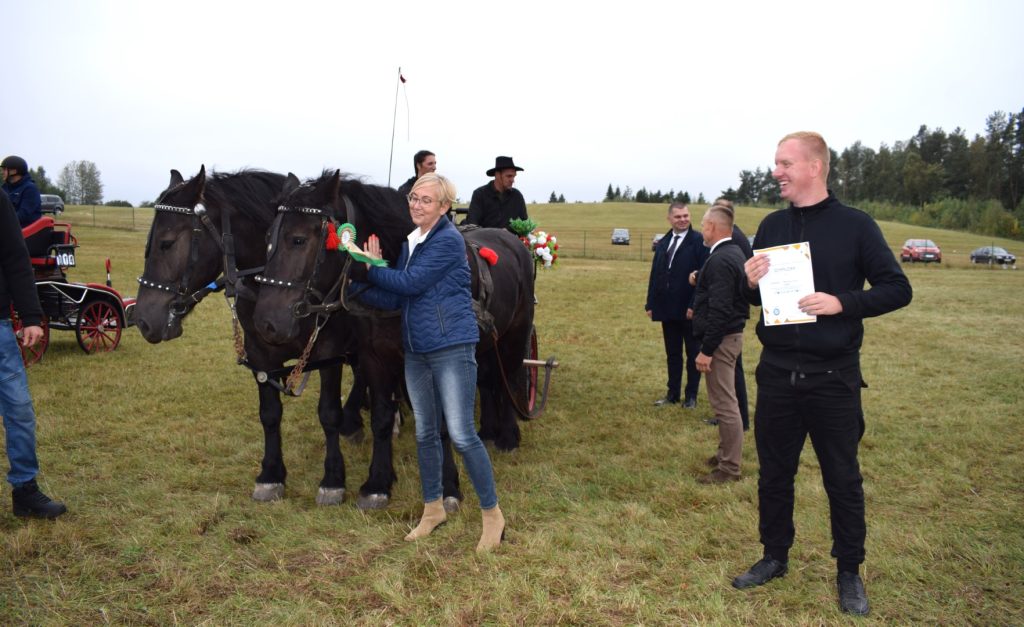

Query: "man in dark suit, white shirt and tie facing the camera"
left=644, top=201, right=708, bottom=409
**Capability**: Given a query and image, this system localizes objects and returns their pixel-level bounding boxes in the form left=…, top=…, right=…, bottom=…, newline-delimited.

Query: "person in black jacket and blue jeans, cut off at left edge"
left=0, top=191, right=67, bottom=518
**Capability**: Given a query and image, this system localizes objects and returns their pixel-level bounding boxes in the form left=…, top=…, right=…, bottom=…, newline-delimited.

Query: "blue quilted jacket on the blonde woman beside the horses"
left=351, top=219, right=480, bottom=352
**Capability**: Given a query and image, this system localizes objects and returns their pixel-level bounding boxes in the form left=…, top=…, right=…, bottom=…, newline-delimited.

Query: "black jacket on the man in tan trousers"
left=693, top=239, right=751, bottom=357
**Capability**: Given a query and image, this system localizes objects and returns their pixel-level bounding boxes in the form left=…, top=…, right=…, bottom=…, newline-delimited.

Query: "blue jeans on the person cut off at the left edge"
left=0, top=320, right=39, bottom=488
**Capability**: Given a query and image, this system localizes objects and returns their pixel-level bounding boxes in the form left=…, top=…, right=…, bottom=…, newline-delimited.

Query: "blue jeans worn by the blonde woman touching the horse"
left=406, top=344, right=498, bottom=509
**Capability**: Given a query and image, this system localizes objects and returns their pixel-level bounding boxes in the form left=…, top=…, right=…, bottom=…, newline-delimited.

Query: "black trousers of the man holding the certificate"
left=754, top=362, right=866, bottom=569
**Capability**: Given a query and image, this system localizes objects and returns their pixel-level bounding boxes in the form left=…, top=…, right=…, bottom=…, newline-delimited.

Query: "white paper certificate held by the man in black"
left=754, top=242, right=818, bottom=327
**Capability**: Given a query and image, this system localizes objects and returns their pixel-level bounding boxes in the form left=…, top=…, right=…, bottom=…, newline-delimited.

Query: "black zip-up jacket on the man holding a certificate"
left=743, top=192, right=913, bottom=373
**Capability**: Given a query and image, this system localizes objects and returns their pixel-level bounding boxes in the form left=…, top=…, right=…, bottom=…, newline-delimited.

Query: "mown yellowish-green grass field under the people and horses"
left=0, top=205, right=1024, bottom=625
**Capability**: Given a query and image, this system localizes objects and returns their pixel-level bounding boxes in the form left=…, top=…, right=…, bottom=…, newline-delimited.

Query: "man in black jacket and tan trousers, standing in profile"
left=693, top=205, right=751, bottom=484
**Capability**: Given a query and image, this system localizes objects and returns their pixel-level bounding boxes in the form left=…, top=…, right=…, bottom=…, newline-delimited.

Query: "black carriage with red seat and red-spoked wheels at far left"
left=11, top=216, right=135, bottom=367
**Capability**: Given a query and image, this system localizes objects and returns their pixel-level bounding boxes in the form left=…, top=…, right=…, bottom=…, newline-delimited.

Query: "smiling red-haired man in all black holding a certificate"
left=732, top=132, right=912, bottom=615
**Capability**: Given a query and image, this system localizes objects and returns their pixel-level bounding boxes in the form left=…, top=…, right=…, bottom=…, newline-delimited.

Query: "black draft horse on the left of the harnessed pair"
left=135, top=167, right=372, bottom=505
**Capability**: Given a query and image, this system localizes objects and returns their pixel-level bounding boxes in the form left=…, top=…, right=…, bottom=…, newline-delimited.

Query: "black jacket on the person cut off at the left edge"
left=0, top=191, right=43, bottom=327
